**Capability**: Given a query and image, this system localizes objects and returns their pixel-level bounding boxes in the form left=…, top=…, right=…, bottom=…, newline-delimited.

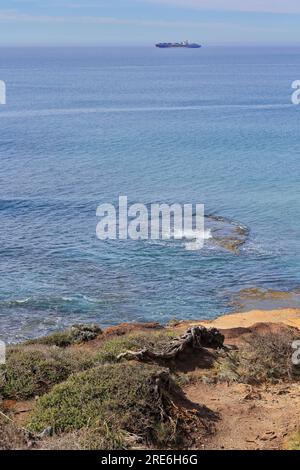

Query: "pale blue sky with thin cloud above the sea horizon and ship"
left=0, top=0, right=300, bottom=45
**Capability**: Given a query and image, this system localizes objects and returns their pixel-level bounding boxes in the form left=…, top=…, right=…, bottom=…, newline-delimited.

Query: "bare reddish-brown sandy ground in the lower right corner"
left=185, top=383, right=300, bottom=450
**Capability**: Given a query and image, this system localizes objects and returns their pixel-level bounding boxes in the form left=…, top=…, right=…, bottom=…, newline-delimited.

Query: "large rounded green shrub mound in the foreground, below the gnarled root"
left=29, top=363, right=191, bottom=448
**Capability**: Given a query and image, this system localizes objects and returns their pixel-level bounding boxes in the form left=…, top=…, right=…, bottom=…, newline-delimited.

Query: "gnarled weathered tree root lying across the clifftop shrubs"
left=117, top=326, right=224, bottom=362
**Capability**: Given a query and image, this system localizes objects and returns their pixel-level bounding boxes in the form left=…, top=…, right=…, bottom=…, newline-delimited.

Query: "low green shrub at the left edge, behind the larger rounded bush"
left=0, top=346, right=94, bottom=399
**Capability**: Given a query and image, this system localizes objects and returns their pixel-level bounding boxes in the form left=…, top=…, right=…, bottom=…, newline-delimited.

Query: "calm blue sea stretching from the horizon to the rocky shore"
left=0, top=47, right=300, bottom=341
